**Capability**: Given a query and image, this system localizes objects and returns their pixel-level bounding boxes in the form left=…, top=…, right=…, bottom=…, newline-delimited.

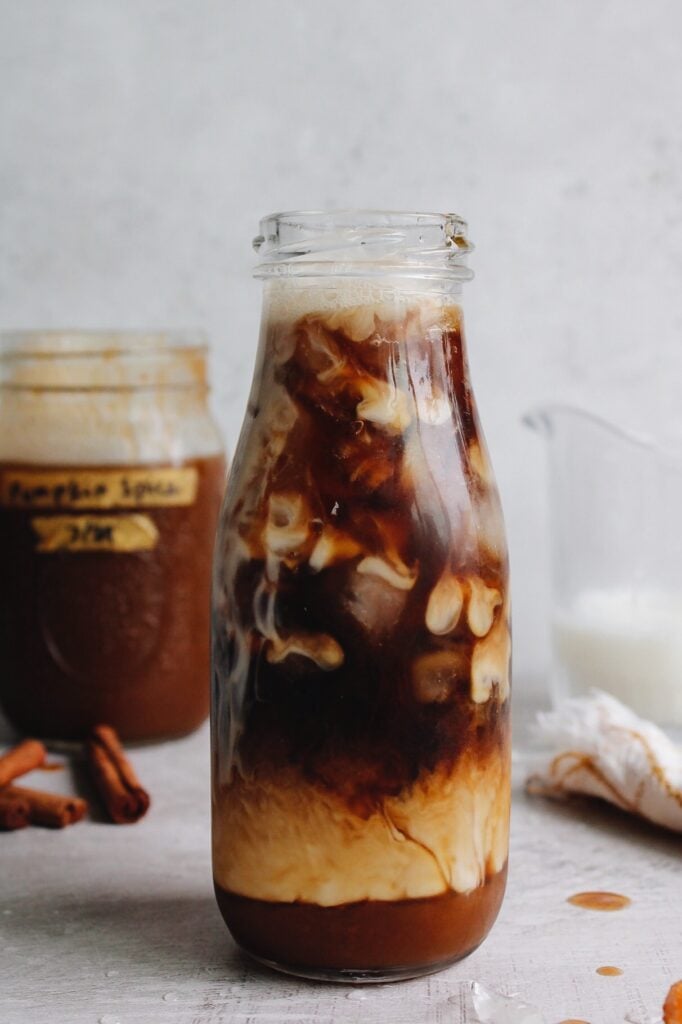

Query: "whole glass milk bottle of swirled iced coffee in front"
left=212, top=212, right=510, bottom=981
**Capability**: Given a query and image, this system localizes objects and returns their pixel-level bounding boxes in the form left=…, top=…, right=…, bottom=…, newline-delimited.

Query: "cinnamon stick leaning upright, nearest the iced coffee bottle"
left=86, top=725, right=150, bottom=825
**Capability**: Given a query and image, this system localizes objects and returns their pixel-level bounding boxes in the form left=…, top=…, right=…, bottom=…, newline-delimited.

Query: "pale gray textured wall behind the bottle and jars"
left=0, top=0, right=682, bottom=687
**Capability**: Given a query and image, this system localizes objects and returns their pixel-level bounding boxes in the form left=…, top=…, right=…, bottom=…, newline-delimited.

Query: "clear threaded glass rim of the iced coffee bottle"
left=253, top=209, right=473, bottom=281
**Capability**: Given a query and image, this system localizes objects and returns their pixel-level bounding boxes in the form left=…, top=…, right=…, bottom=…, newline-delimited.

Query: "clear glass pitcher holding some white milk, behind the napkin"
left=525, top=406, right=682, bottom=726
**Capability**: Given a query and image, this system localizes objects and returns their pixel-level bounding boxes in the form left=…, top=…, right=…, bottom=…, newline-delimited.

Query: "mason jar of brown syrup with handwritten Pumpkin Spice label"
left=0, top=331, right=225, bottom=740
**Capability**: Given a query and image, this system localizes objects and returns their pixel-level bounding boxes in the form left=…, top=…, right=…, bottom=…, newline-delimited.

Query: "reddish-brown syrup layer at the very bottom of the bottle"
left=215, top=867, right=507, bottom=977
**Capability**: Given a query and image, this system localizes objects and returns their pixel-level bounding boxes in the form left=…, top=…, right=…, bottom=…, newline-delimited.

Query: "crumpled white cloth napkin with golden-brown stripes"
left=526, top=690, right=682, bottom=833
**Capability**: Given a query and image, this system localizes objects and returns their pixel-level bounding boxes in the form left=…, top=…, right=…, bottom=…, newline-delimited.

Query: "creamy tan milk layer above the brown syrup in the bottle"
left=213, top=750, right=510, bottom=906
